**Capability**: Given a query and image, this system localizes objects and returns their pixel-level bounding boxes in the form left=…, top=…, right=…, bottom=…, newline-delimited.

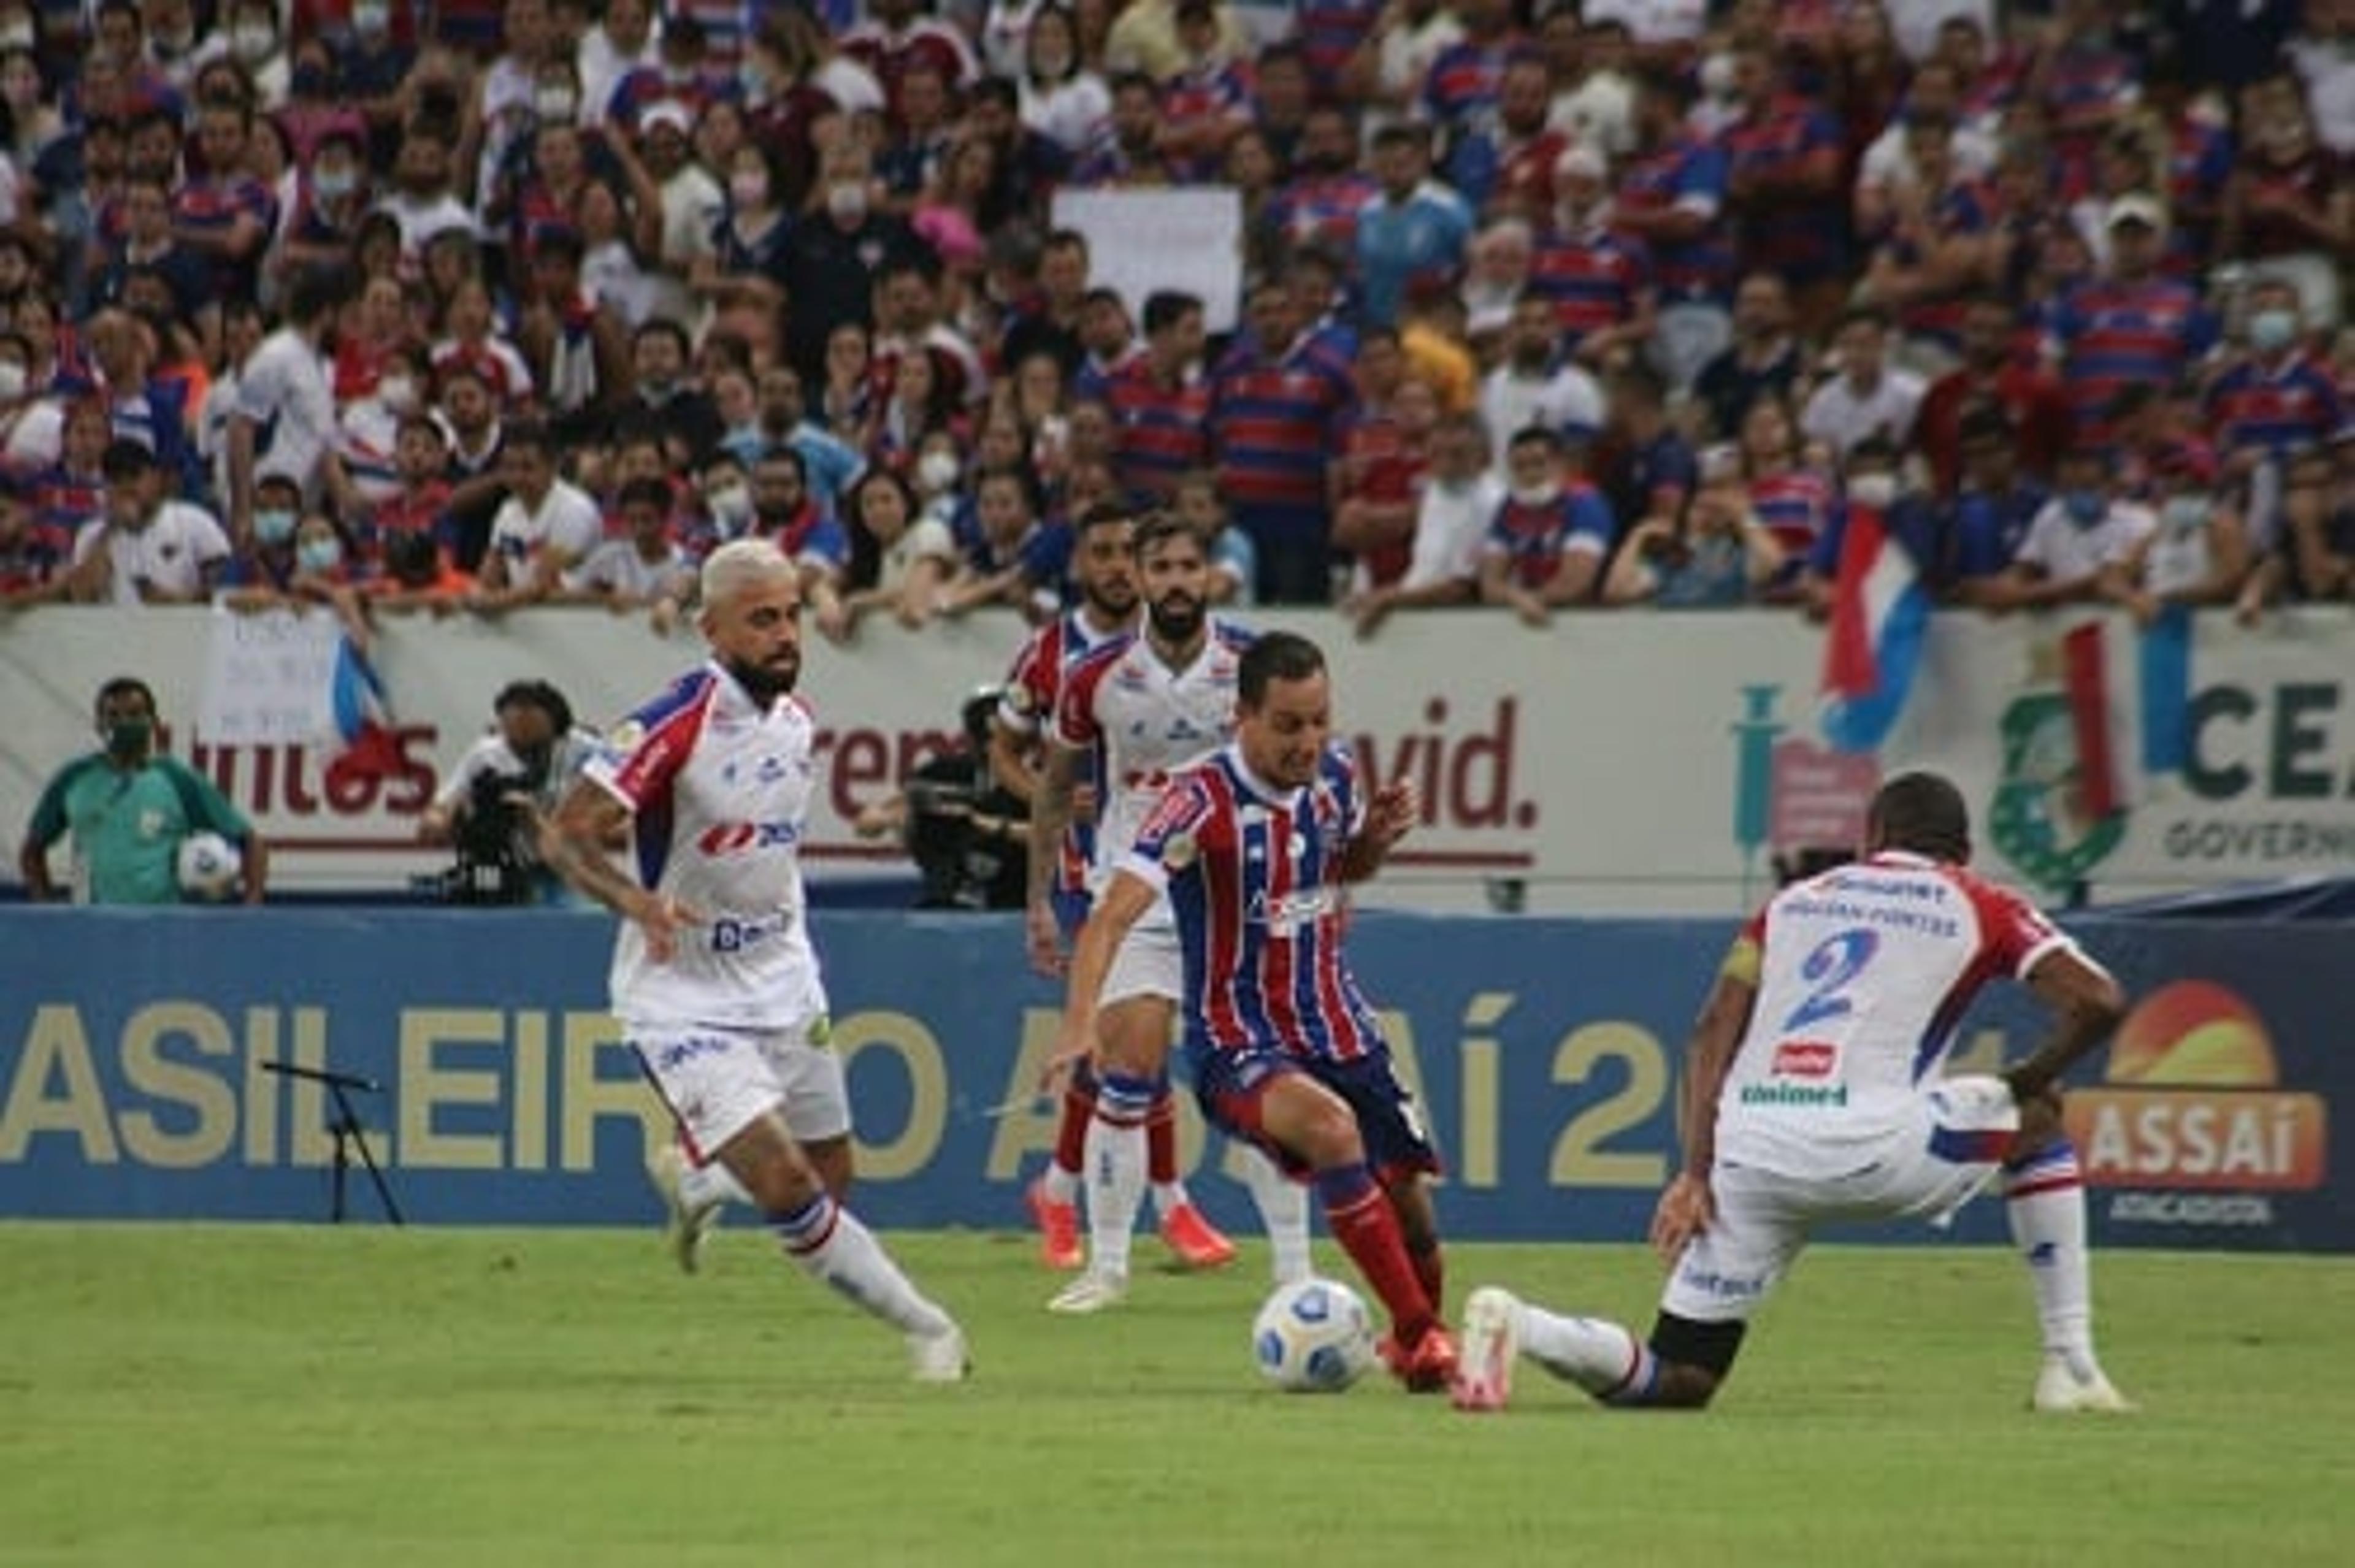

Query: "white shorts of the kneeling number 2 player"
left=1660, top=1078, right=2021, bottom=1323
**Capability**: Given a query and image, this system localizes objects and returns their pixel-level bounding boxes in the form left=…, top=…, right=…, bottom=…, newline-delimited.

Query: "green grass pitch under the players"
left=0, top=1224, right=2355, bottom=1568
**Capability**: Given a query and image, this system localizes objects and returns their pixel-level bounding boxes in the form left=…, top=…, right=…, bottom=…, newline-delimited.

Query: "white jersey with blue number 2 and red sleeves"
left=1717, top=852, right=2075, bottom=1175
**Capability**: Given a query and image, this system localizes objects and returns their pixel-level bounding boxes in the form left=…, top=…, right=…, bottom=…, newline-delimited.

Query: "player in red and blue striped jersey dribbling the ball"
left=1057, top=631, right=1455, bottom=1391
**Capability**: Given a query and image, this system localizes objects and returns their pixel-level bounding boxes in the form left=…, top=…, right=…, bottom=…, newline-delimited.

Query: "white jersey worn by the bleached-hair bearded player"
left=589, top=664, right=827, bottom=1029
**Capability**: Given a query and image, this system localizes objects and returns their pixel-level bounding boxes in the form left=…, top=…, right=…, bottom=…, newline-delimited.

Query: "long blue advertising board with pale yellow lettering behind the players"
left=0, top=909, right=2355, bottom=1250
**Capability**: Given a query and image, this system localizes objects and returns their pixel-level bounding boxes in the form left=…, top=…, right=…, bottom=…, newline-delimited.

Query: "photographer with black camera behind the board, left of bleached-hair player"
left=417, top=681, right=598, bottom=904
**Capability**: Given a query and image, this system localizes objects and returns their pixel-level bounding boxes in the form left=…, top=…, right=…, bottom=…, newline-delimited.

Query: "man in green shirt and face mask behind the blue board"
left=17, top=676, right=269, bottom=904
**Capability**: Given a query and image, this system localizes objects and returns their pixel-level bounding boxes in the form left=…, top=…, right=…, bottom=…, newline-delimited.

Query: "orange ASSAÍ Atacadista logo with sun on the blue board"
left=2068, top=979, right=2329, bottom=1196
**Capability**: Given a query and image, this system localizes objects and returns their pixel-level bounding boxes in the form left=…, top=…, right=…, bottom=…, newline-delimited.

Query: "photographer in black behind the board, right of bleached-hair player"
left=855, top=687, right=1029, bottom=909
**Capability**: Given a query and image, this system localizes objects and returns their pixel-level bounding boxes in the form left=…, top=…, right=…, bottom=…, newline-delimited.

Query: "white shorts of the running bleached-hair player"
left=629, top=1015, right=850, bottom=1161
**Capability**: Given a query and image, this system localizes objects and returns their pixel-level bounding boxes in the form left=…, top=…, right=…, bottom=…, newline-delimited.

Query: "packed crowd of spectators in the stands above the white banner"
left=0, top=0, right=2355, bottom=640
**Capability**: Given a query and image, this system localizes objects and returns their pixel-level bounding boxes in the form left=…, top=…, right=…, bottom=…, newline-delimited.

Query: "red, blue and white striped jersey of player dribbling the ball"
left=1121, top=744, right=1385, bottom=1062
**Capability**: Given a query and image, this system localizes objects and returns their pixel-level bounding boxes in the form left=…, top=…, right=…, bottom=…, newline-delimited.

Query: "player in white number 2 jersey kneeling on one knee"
left=1455, top=772, right=2131, bottom=1413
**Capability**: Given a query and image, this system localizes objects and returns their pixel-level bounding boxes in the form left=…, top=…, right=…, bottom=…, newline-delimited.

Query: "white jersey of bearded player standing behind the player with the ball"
left=1055, top=614, right=1250, bottom=892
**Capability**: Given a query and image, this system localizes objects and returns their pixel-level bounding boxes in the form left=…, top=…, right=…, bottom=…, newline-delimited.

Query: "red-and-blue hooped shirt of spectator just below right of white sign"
left=1208, top=337, right=1357, bottom=511
